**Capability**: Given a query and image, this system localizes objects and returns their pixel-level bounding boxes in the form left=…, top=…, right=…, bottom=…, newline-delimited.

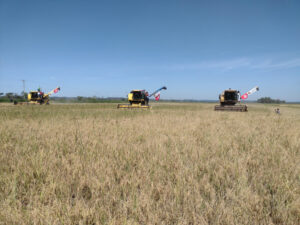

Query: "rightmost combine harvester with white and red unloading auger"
left=215, top=86, right=259, bottom=112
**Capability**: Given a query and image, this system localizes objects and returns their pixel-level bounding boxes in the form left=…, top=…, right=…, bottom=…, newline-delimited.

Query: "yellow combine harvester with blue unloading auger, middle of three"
left=118, top=86, right=167, bottom=109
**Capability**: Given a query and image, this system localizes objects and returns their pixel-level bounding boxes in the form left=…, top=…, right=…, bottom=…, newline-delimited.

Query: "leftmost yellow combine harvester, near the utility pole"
left=14, top=87, right=60, bottom=105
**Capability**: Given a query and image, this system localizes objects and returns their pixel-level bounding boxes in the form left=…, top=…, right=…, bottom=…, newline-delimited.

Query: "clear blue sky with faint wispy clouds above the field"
left=0, top=0, right=300, bottom=101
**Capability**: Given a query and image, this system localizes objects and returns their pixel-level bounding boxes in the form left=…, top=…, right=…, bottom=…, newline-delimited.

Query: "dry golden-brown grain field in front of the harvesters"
left=0, top=103, right=300, bottom=225
